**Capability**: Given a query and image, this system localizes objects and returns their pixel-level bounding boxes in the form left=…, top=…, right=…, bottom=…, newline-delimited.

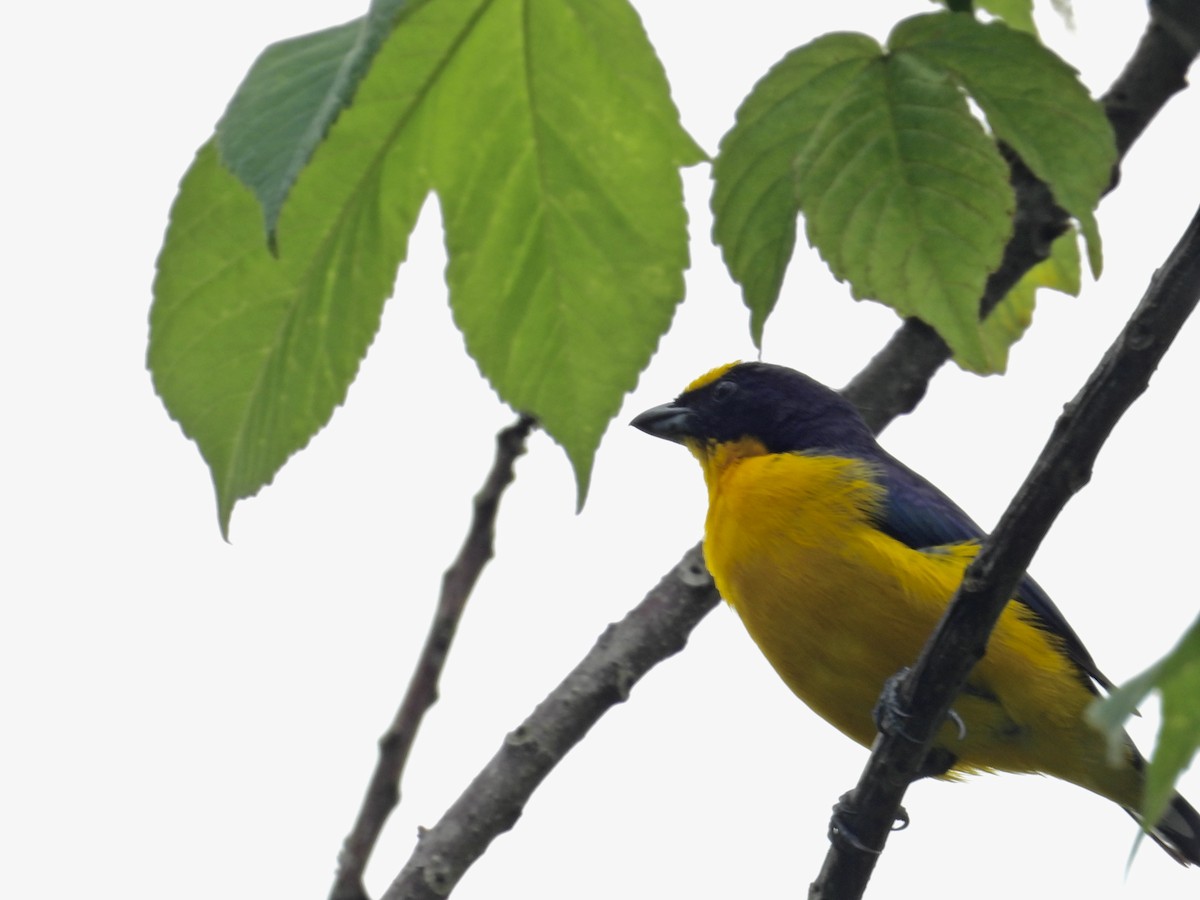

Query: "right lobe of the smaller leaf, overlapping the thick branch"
left=888, top=13, right=1117, bottom=276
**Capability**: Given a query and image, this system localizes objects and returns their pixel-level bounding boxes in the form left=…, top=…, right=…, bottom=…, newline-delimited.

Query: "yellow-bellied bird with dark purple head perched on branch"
left=630, top=362, right=1200, bottom=865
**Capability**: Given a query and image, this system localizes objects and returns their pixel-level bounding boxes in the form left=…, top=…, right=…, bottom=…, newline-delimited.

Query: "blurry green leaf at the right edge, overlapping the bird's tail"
left=1087, top=619, right=1200, bottom=822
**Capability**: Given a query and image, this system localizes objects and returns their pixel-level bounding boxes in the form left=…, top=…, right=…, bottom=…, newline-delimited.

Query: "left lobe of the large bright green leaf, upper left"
left=148, top=0, right=462, bottom=534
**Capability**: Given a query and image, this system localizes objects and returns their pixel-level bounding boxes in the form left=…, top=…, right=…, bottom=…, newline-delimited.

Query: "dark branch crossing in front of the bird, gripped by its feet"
left=809, top=202, right=1200, bottom=900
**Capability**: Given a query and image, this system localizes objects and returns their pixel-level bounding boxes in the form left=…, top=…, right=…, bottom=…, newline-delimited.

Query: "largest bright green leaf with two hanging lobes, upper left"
left=149, top=0, right=702, bottom=530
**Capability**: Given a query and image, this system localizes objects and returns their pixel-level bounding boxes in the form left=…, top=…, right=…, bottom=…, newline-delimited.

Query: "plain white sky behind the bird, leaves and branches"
left=0, top=0, right=1200, bottom=900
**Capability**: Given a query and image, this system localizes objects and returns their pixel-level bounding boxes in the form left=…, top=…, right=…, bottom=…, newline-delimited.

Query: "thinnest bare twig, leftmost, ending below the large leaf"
left=329, top=415, right=535, bottom=900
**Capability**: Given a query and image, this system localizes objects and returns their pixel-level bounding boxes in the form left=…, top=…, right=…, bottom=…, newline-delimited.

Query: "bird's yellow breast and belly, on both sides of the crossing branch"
left=704, top=454, right=1140, bottom=803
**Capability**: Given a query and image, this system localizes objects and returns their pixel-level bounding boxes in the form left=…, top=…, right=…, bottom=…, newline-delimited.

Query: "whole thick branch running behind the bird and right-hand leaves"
left=374, top=0, right=1200, bottom=900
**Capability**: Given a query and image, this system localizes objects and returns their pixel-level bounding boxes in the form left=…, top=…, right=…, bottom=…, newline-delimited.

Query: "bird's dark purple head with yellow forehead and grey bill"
left=630, top=362, right=877, bottom=469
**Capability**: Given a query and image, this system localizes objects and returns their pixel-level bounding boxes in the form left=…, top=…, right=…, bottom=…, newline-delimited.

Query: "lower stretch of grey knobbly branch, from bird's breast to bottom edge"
left=383, top=546, right=720, bottom=900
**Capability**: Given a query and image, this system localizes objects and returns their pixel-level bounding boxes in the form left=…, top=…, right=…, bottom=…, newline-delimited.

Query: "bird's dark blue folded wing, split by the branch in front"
left=878, top=454, right=1112, bottom=690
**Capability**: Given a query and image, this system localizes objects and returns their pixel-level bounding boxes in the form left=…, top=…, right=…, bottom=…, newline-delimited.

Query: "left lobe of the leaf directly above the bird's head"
left=712, top=34, right=882, bottom=346
